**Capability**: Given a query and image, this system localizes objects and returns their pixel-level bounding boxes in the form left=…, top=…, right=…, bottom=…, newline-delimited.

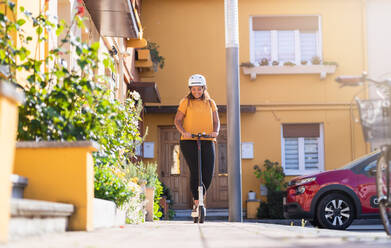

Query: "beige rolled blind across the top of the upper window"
left=252, top=16, right=319, bottom=31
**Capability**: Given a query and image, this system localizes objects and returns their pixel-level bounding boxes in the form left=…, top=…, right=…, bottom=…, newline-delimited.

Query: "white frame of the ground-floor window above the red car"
left=281, top=123, right=324, bottom=176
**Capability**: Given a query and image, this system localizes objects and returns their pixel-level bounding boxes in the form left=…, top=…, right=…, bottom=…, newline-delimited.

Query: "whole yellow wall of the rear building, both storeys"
left=142, top=0, right=369, bottom=206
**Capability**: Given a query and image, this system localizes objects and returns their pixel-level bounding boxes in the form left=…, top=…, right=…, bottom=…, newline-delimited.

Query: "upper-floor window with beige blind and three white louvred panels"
left=250, top=16, right=321, bottom=65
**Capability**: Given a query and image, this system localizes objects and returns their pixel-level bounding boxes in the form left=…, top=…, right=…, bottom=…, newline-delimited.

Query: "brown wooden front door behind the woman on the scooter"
left=159, top=126, right=228, bottom=209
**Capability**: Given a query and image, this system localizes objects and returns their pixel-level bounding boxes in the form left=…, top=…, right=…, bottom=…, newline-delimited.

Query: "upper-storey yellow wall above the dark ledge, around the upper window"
left=142, top=0, right=365, bottom=105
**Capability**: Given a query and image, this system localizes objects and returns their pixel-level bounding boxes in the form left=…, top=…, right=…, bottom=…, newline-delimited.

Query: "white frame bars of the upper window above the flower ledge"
left=249, top=15, right=323, bottom=65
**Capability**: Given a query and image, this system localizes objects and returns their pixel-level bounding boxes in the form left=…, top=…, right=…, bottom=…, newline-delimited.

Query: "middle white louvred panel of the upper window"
left=278, top=31, right=295, bottom=62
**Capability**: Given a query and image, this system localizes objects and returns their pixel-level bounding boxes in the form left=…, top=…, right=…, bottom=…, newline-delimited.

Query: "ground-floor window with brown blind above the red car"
left=281, top=123, right=324, bottom=175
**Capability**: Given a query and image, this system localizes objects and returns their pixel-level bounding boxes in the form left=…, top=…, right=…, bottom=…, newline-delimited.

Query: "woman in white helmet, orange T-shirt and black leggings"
left=175, top=74, right=220, bottom=221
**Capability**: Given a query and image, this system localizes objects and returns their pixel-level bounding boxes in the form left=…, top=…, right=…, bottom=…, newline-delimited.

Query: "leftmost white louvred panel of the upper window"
left=254, top=31, right=272, bottom=63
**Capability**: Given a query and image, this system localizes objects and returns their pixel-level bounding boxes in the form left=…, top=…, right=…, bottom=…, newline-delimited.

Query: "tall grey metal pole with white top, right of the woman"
left=224, top=0, right=243, bottom=222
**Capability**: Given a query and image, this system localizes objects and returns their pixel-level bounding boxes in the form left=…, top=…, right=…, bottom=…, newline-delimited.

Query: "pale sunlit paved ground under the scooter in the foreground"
left=0, top=221, right=391, bottom=248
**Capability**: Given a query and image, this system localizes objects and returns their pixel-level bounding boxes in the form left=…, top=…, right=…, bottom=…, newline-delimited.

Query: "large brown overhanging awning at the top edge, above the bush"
left=84, top=0, right=142, bottom=39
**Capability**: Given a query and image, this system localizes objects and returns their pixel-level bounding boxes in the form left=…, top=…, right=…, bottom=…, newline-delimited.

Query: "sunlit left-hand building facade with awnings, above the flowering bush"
left=15, top=0, right=160, bottom=105
